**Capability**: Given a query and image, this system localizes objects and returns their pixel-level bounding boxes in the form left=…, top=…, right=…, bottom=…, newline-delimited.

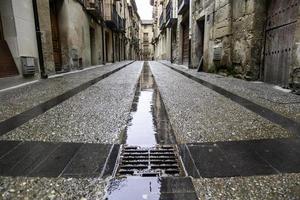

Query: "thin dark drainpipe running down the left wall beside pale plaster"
left=32, top=0, right=48, bottom=79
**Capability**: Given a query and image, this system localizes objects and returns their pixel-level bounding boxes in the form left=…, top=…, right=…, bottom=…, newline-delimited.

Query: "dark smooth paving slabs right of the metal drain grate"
left=180, top=138, right=300, bottom=178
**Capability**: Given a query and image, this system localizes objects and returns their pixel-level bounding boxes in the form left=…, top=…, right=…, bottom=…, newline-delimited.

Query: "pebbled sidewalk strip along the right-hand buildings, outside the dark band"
left=162, top=61, right=300, bottom=122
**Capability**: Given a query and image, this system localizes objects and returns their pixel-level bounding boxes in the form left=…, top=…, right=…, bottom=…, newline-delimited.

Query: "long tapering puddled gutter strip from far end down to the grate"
left=126, top=62, right=175, bottom=147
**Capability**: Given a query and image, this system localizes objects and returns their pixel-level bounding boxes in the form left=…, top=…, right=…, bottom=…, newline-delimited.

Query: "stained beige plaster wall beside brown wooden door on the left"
left=53, top=0, right=103, bottom=69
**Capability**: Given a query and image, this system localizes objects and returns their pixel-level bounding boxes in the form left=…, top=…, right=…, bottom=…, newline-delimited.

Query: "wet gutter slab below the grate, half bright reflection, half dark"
left=105, top=176, right=198, bottom=200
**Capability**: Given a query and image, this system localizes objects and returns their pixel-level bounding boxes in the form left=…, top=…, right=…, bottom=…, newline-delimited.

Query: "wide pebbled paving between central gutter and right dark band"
left=150, top=62, right=295, bottom=143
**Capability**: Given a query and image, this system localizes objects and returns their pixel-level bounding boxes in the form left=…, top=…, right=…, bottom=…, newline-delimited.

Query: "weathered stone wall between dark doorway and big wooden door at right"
left=191, top=0, right=266, bottom=80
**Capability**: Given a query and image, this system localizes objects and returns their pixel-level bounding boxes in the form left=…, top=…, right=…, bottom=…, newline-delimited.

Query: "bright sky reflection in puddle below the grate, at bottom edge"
left=106, top=176, right=161, bottom=200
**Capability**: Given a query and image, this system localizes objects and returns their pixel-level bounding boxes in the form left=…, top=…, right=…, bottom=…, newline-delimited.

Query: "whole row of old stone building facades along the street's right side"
left=151, top=0, right=300, bottom=87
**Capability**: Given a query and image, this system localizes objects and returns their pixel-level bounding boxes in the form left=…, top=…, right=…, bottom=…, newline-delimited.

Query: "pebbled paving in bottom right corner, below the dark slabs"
left=193, top=174, right=300, bottom=200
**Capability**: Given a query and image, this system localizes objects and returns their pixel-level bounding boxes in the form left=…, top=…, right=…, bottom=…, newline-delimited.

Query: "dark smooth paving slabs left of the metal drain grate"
left=0, top=141, right=119, bottom=178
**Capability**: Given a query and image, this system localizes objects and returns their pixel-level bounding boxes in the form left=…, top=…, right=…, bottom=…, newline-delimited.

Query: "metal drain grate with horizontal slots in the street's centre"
left=117, top=145, right=183, bottom=176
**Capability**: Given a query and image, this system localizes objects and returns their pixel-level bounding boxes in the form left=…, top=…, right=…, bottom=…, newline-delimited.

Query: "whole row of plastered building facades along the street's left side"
left=0, top=0, right=140, bottom=77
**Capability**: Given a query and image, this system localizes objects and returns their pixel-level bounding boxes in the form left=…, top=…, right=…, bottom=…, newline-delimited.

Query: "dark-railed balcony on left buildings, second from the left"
left=104, top=0, right=119, bottom=30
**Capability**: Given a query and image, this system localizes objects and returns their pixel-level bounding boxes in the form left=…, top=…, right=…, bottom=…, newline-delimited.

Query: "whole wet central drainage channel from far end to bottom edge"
left=105, top=62, right=197, bottom=200
